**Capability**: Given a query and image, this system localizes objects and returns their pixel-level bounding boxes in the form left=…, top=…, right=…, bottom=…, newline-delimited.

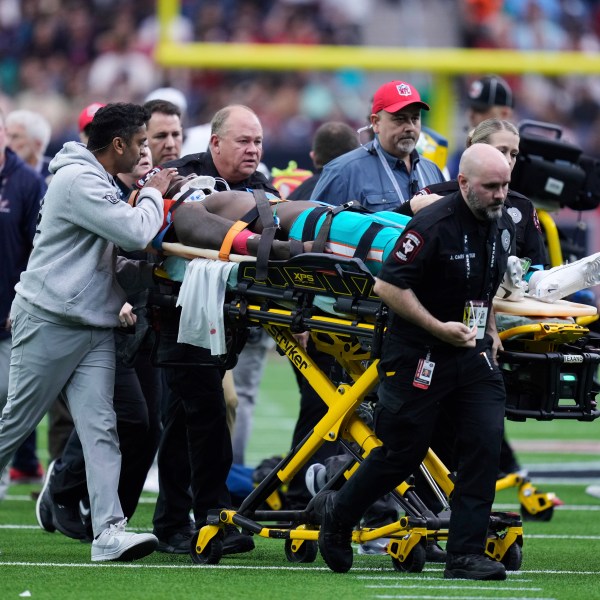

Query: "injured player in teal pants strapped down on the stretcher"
left=135, top=175, right=600, bottom=302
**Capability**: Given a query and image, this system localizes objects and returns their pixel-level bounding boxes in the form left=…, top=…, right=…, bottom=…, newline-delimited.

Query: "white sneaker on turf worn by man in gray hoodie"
left=92, top=519, right=158, bottom=562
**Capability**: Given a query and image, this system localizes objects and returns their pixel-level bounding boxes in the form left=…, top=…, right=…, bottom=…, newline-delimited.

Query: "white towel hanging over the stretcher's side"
left=177, top=258, right=235, bottom=356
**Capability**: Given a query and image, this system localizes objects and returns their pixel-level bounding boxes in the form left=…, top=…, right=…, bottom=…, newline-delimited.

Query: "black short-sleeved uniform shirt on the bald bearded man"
left=378, top=192, right=515, bottom=347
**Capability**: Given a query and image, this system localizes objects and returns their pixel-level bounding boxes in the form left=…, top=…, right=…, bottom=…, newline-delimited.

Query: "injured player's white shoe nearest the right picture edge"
left=529, top=252, right=600, bottom=302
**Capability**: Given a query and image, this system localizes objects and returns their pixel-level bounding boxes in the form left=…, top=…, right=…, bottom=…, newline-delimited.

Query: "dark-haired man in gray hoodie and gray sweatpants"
left=0, top=104, right=176, bottom=561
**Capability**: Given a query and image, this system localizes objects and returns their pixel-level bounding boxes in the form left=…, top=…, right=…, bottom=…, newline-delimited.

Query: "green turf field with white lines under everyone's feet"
left=0, top=355, right=600, bottom=600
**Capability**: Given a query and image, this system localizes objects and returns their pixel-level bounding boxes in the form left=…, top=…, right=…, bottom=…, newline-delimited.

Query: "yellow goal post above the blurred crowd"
left=155, top=0, right=600, bottom=137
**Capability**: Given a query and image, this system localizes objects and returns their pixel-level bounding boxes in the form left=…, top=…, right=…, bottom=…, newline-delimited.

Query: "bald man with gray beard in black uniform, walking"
left=315, top=144, right=515, bottom=580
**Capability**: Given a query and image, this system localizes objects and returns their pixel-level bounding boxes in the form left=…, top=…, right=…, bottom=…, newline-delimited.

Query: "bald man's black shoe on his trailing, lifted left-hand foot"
left=314, top=490, right=354, bottom=573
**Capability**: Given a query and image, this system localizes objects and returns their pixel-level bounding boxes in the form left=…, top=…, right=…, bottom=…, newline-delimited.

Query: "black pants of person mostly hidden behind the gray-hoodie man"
left=50, top=351, right=161, bottom=519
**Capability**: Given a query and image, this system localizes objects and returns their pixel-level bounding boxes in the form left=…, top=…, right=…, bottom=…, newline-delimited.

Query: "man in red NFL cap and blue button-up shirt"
left=310, top=80, right=444, bottom=216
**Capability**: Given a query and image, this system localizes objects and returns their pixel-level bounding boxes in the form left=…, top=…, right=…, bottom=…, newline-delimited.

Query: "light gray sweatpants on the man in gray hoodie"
left=0, top=305, right=123, bottom=536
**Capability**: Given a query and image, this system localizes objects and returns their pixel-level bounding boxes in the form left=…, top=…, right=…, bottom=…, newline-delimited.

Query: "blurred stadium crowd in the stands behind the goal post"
left=0, top=0, right=600, bottom=162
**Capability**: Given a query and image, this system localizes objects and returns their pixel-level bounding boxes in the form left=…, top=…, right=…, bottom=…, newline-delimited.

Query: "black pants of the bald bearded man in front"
left=335, top=345, right=505, bottom=554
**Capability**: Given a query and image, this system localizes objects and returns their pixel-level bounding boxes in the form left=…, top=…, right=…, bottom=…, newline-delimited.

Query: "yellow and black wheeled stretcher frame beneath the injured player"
left=151, top=254, right=523, bottom=572
